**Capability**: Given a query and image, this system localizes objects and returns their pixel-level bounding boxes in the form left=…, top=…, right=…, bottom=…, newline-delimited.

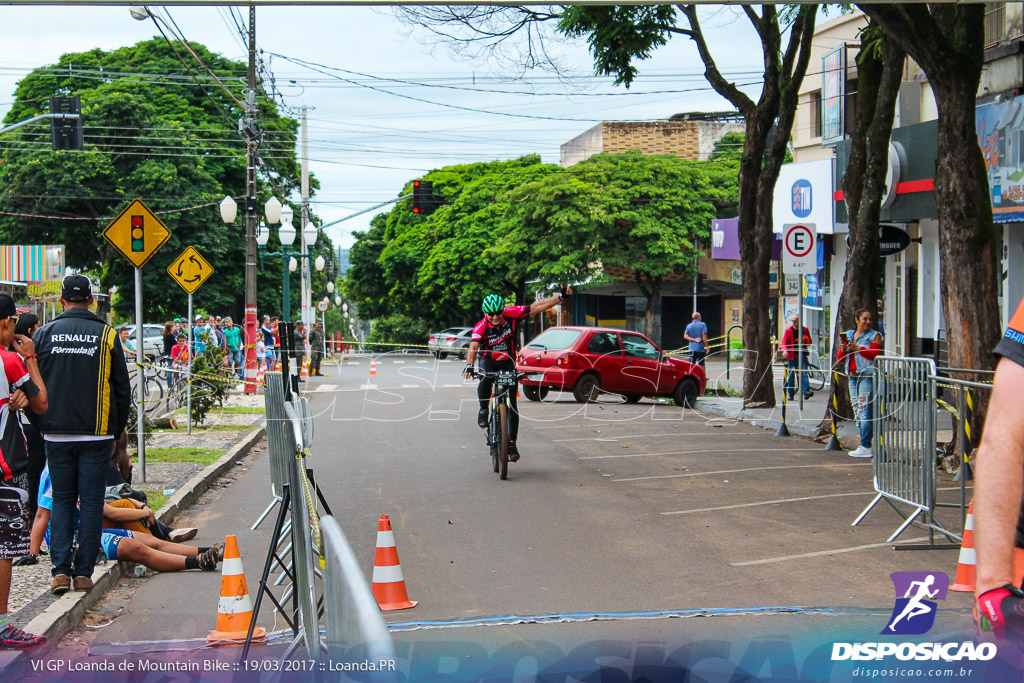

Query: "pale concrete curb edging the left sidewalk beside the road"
left=0, top=427, right=266, bottom=680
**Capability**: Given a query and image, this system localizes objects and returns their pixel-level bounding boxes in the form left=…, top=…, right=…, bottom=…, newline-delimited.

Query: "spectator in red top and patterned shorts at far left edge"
left=0, top=292, right=47, bottom=650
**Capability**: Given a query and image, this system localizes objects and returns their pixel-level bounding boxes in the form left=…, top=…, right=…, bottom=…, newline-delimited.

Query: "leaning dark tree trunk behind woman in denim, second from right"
left=818, top=27, right=906, bottom=433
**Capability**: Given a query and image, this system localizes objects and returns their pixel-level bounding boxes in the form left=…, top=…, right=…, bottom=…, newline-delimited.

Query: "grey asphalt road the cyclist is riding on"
left=59, top=355, right=970, bottom=679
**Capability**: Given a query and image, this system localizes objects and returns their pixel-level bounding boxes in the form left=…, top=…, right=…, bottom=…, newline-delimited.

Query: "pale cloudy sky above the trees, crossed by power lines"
left=0, top=5, right=761, bottom=247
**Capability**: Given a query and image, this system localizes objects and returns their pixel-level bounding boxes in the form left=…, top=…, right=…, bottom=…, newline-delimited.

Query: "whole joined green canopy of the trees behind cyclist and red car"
left=345, top=153, right=736, bottom=341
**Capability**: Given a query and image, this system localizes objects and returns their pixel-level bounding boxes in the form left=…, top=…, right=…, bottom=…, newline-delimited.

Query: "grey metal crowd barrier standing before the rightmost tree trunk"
left=852, top=356, right=959, bottom=549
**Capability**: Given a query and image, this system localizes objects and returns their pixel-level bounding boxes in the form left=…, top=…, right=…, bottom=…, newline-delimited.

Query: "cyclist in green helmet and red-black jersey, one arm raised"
left=462, top=288, right=572, bottom=462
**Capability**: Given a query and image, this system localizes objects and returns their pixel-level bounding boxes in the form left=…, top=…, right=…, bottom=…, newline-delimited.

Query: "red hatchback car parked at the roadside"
left=516, top=328, right=708, bottom=408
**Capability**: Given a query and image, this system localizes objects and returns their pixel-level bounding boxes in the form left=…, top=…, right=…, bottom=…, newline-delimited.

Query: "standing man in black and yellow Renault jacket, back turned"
left=35, top=274, right=131, bottom=595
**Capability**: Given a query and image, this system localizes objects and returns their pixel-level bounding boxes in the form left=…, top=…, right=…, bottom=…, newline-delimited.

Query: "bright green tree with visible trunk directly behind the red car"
left=510, top=153, right=720, bottom=335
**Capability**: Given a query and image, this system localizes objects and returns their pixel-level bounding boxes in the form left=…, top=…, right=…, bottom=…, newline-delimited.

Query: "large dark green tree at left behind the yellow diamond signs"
left=0, top=39, right=317, bottom=321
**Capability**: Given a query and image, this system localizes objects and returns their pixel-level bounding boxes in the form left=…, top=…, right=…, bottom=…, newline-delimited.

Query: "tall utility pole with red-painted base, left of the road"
left=242, top=5, right=260, bottom=394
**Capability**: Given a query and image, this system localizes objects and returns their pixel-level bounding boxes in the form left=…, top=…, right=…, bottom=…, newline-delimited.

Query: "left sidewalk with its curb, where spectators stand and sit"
left=0, top=390, right=265, bottom=671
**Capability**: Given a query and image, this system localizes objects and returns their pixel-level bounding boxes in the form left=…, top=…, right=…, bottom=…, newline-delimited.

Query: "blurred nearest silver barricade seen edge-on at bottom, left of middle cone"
left=321, top=516, right=395, bottom=681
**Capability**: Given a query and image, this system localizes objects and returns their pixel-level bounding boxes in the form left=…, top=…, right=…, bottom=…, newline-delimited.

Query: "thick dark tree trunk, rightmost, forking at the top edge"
left=861, top=4, right=1001, bottom=433
